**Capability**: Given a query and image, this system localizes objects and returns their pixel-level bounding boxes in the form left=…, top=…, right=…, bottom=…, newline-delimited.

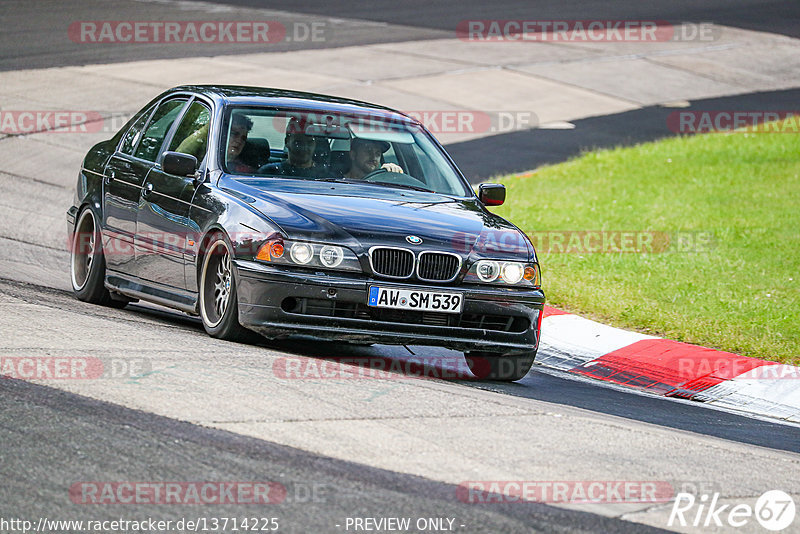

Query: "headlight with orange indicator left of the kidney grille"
left=256, top=239, right=361, bottom=272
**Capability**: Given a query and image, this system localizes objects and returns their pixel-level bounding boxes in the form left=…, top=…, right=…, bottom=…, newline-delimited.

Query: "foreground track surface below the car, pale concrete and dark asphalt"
left=0, top=281, right=800, bottom=532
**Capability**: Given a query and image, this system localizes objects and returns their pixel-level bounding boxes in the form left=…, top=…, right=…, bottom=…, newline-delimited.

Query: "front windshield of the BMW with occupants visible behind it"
left=220, top=107, right=470, bottom=197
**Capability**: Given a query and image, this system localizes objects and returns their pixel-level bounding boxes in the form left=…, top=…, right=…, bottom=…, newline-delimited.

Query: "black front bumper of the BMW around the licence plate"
left=236, top=260, right=544, bottom=352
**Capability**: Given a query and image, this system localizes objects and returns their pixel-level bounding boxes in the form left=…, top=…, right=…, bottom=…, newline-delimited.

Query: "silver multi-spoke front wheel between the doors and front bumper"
left=198, top=233, right=254, bottom=342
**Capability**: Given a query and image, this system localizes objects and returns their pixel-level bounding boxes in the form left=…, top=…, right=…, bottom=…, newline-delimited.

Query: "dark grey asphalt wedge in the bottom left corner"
left=0, top=372, right=672, bottom=533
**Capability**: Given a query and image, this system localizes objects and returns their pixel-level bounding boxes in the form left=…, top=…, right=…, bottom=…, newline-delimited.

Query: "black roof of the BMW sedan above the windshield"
left=168, top=85, right=417, bottom=123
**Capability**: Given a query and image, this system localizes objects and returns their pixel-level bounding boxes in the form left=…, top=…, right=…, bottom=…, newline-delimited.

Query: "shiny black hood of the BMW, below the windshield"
left=231, top=180, right=531, bottom=258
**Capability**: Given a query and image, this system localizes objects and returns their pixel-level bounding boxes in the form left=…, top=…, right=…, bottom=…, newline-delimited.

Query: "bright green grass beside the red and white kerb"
left=496, top=127, right=800, bottom=365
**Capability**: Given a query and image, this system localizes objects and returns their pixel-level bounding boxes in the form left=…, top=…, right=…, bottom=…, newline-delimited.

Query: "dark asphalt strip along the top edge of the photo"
left=0, top=0, right=800, bottom=70
